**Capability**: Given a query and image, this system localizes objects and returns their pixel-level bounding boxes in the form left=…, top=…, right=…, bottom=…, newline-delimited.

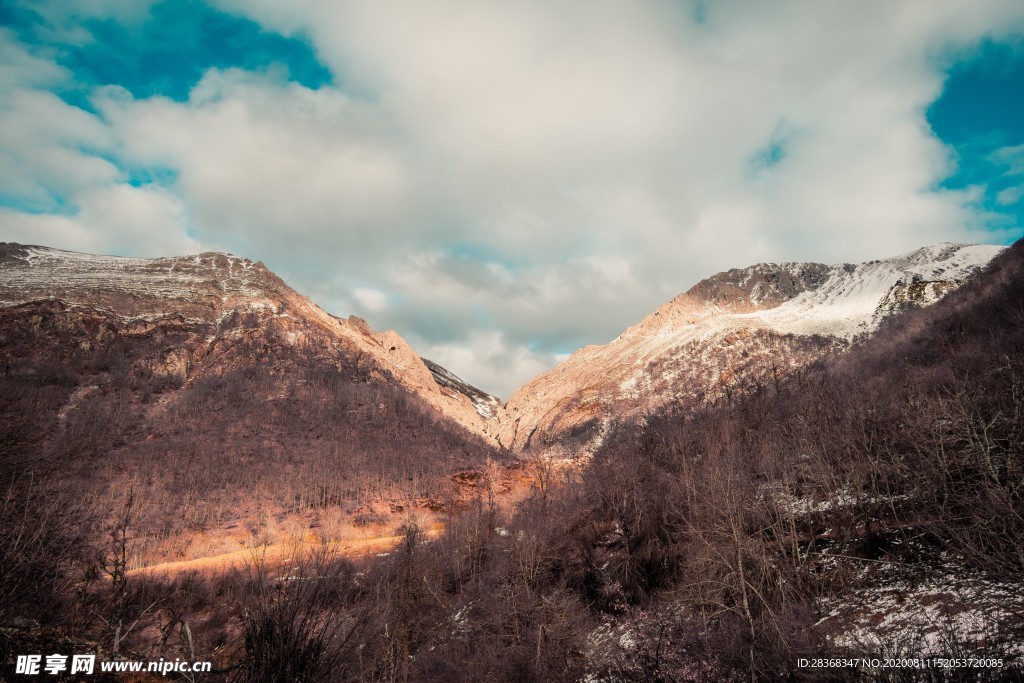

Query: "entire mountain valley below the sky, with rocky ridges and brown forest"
left=0, top=243, right=1024, bottom=681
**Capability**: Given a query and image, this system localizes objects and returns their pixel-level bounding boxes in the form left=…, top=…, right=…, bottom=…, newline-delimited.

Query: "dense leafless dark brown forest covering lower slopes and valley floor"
left=0, top=244, right=1024, bottom=681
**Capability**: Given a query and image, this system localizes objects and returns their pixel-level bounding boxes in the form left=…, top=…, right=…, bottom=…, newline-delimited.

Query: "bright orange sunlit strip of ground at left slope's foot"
left=128, top=523, right=444, bottom=575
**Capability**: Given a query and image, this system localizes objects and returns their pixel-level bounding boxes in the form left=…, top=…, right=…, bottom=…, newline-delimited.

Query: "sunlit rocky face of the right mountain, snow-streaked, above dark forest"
left=499, top=244, right=1001, bottom=456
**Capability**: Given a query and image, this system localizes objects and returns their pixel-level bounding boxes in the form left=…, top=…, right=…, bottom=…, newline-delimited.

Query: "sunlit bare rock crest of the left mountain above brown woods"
left=0, top=243, right=497, bottom=438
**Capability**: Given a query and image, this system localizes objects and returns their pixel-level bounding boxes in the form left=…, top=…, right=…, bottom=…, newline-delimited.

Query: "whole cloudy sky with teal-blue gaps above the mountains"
left=0, top=0, right=1024, bottom=397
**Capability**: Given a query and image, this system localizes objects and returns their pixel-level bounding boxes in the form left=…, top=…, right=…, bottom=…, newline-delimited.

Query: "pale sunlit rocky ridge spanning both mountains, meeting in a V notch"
left=0, top=243, right=1002, bottom=455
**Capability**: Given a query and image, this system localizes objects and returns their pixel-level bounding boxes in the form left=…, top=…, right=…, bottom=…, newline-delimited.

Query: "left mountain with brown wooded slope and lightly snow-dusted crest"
left=0, top=245, right=503, bottom=565
